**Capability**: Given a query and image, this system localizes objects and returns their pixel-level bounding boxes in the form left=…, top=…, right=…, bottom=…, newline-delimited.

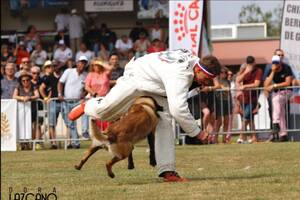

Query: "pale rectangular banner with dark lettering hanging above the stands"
left=84, top=0, right=133, bottom=12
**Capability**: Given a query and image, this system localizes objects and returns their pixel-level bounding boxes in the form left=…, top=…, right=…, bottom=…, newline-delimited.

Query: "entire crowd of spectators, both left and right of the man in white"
left=1, top=9, right=299, bottom=149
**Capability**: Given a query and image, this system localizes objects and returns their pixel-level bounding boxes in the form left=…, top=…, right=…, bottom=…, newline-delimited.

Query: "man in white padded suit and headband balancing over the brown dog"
left=69, top=49, right=220, bottom=182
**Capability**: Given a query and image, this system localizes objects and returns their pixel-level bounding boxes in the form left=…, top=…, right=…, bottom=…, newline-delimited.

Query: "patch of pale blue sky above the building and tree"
left=211, top=0, right=283, bottom=25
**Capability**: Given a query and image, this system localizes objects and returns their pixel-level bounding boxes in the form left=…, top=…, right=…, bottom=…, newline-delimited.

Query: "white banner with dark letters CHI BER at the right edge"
left=280, top=0, right=300, bottom=79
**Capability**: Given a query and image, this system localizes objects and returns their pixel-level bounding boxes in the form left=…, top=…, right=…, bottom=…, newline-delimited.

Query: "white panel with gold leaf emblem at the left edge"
left=1, top=99, right=17, bottom=151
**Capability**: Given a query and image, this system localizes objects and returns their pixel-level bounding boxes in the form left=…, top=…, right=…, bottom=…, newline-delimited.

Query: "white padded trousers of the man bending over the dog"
left=84, top=77, right=175, bottom=174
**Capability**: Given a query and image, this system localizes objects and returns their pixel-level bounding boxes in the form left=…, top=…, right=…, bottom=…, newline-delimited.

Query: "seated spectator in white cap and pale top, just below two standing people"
left=53, top=40, right=73, bottom=70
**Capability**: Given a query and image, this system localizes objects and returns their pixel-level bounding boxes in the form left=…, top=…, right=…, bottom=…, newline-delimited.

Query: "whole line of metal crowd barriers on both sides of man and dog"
left=11, top=86, right=300, bottom=148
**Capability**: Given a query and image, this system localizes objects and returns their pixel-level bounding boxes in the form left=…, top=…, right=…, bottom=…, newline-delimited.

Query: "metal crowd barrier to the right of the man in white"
left=174, top=86, right=300, bottom=144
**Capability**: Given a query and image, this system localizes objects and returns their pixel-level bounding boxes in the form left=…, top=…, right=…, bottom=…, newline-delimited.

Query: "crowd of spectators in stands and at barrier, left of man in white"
left=1, top=8, right=166, bottom=149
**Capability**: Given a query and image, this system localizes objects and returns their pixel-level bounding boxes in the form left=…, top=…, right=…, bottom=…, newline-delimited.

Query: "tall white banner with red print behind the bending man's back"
left=169, top=0, right=203, bottom=55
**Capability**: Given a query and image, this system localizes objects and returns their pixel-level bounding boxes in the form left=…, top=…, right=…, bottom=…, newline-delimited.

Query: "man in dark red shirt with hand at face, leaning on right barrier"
left=236, top=56, right=263, bottom=144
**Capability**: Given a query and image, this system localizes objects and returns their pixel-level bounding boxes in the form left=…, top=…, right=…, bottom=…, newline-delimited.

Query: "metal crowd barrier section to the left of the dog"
left=17, top=98, right=93, bottom=151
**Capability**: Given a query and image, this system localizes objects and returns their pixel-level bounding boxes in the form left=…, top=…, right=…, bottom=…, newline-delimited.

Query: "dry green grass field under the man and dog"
left=1, top=142, right=300, bottom=200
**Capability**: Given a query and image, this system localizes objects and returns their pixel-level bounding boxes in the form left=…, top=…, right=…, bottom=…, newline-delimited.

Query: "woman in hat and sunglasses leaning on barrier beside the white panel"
left=13, top=71, right=39, bottom=149
